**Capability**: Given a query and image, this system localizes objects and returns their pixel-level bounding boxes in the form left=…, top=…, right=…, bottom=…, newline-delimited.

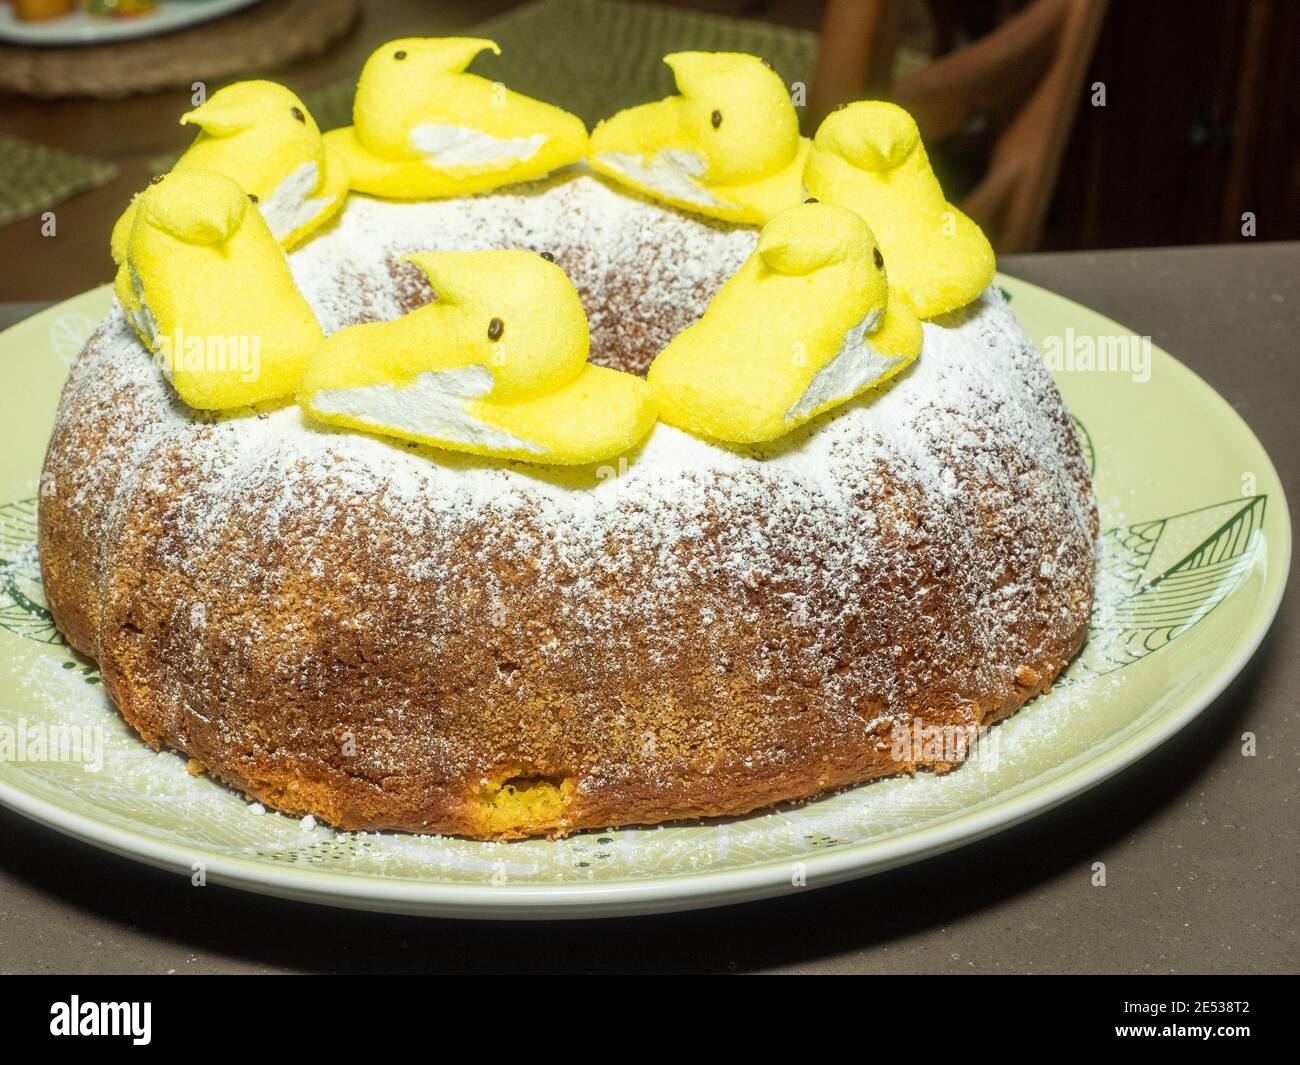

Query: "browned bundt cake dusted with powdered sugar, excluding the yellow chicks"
left=39, top=42, right=1096, bottom=839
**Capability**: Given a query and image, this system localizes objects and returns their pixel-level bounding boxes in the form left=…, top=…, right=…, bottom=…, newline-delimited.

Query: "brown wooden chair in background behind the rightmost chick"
left=809, top=0, right=1106, bottom=254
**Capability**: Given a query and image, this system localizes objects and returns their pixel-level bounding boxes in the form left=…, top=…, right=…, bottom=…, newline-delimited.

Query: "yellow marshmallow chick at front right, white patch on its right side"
left=649, top=203, right=922, bottom=443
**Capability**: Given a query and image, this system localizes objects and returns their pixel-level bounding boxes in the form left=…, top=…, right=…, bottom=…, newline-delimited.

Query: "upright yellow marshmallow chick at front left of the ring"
left=117, top=169, right=324, bottom=410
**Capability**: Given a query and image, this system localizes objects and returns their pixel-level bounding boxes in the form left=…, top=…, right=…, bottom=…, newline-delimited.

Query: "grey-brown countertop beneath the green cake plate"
left=0, top=243, right=1300, bottom=973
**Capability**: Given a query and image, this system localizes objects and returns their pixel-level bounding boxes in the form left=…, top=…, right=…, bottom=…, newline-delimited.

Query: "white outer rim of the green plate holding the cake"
left=0, top=279, right=1292, bottom=919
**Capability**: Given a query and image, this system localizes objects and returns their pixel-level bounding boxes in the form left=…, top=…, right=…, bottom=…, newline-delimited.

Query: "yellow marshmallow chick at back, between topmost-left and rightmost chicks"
left=588, top=52, right=810, bottom=225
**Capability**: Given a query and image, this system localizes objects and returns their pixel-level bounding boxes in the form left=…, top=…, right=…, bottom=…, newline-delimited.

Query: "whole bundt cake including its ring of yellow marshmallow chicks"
left=39, top=38, right=1097, bottom=839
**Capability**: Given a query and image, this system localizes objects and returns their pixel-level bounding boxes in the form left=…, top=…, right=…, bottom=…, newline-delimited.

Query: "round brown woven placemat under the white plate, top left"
left=0, top=0, right=358, bottom=98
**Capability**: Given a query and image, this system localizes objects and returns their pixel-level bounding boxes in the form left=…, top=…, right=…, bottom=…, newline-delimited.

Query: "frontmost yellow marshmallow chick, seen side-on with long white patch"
left=298, top=250, right=655, bottom=466
